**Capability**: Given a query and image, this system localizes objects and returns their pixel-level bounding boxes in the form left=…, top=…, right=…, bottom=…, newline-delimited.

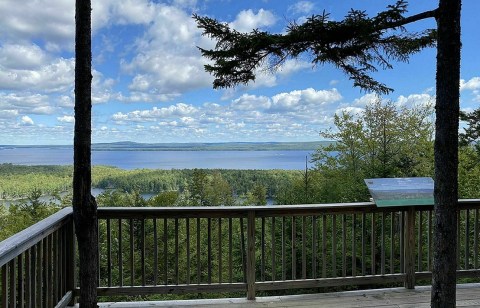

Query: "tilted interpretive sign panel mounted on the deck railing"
left=365, top=178, right=433, bottom=207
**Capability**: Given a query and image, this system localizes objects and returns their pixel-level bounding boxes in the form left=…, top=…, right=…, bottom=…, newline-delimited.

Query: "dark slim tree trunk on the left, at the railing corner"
left=73, top=0, right=98, bottom=308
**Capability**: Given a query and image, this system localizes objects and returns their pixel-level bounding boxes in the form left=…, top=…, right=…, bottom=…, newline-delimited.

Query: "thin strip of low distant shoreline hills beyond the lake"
left=0, top=141, right=334, bottom=151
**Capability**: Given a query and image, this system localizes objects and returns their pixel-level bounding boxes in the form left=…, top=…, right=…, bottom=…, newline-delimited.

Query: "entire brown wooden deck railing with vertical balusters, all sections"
left=0, top=200, right=480, bottom=307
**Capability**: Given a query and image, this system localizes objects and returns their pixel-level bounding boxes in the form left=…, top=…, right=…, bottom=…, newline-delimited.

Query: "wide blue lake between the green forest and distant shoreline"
left=0, top=147, right=314, bottom=170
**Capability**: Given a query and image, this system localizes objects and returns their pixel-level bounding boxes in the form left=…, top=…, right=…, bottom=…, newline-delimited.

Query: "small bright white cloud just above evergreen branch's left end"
left=230, top=9, right=277, bottom=32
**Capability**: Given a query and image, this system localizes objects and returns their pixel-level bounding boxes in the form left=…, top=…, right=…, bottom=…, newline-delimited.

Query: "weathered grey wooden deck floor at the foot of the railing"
left=93, top=284, right=480, bottom=308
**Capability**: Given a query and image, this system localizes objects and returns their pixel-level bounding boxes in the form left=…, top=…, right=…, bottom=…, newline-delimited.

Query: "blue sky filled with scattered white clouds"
left=0, top=0, right=480, bottom=144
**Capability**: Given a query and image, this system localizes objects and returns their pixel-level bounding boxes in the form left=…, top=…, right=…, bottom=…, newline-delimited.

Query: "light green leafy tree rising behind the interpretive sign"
left=306, top=99, right=433, bottom=203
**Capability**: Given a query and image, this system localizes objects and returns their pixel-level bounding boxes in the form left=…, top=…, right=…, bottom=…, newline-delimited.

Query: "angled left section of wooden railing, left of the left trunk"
left=0, top=208, right=75, bottom=308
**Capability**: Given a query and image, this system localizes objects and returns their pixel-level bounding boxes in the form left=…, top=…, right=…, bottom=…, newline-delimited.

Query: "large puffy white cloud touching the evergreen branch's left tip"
left=121, top=4, right=213, bottom=97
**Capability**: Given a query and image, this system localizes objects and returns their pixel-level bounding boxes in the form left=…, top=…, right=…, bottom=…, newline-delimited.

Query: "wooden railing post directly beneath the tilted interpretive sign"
left=404, top=207, right=415, bottom=289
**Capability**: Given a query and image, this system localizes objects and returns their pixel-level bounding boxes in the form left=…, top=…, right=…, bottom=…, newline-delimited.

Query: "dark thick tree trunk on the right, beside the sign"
left=431, top=0, right=461, bottom=307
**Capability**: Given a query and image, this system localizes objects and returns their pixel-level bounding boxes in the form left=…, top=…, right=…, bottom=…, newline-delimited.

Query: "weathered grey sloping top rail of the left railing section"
left=0, top=207, right=73, bottom=266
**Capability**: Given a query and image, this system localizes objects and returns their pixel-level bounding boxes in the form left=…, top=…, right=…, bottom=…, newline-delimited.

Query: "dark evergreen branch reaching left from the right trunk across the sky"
left=194, top=0, right=436, bottom=93
